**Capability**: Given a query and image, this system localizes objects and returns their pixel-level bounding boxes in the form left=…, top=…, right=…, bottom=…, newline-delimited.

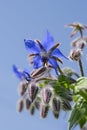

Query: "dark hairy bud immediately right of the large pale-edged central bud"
left=52, top=97, right=61, bottom=112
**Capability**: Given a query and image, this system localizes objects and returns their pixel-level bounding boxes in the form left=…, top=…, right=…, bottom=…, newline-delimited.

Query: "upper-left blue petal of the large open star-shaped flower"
left=24, top=39, right=40, bottom=53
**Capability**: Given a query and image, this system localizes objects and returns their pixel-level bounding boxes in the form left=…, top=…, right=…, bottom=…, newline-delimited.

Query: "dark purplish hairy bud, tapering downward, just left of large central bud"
left=28, top=84, right=38, bottom=102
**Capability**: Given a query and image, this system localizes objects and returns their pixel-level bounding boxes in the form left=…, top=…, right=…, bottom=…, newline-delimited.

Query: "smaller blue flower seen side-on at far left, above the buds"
left=13, top=65, right=31, bottom=81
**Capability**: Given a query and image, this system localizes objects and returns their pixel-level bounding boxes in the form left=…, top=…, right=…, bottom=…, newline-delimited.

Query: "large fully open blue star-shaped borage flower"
left=24, top=31, right=68, bottom=75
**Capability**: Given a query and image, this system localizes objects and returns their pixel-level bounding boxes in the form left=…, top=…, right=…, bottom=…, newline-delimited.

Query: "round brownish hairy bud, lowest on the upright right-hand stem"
left=69, top=49, right=82, bottom=61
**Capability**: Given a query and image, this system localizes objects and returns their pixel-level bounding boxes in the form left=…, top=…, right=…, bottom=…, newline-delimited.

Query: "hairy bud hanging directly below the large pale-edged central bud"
left=40, top=104, right=49, bottom=118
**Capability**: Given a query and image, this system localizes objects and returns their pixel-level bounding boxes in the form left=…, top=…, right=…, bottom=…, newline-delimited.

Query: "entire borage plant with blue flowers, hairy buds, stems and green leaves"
left=13, top=23, right=87, bottom=130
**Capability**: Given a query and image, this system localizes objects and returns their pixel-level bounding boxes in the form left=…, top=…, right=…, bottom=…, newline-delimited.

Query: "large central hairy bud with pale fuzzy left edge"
left=42, top=87, right=52, bottom=104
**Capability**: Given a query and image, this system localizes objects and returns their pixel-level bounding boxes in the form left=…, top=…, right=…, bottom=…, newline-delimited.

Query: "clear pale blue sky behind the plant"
left=0, top=0, right=87, bottom=130
